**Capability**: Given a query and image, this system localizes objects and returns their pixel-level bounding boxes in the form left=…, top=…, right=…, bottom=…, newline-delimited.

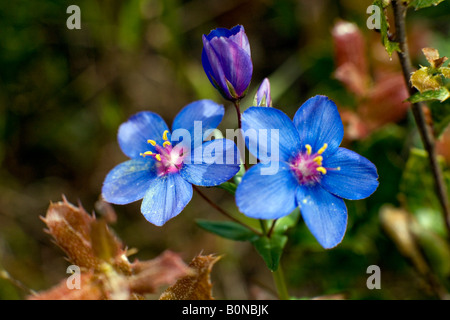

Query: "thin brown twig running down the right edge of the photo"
left=392, top=0, right=450, bottom=236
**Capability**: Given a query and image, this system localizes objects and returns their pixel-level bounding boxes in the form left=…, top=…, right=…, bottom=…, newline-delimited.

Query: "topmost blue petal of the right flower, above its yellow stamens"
left=294, top=96, right=344, bottom=159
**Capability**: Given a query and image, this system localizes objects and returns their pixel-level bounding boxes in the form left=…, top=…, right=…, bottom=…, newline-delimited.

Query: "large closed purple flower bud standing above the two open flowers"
left=202, top=25, right=253, bottom=101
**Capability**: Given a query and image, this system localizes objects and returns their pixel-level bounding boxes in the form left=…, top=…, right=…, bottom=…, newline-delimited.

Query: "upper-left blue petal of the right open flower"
left=242, top=107, right=301, bottom=163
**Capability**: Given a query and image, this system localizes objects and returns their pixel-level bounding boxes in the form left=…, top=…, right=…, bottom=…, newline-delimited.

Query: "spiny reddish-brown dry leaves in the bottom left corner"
left=33, top=198, right=192, bottom=300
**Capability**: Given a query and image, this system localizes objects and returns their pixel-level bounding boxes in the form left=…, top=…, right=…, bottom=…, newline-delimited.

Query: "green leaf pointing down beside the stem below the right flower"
left=252, top=234, right=288, bottom=271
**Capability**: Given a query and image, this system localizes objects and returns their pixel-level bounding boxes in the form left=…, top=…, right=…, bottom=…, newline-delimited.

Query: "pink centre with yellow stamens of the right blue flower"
left=291, top=143, right=341, bottom=185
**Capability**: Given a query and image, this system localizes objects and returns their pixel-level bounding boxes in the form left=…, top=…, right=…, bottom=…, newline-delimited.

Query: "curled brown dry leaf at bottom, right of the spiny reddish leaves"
left=159, top=255, right=220, bottom=300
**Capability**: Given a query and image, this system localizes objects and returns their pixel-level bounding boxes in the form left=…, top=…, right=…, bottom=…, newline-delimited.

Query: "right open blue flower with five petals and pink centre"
left=236, top=96, right=378, bottom=249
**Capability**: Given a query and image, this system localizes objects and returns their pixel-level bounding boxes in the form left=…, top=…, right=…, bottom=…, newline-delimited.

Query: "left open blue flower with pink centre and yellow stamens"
left=102, top=100, right=240, bottom=226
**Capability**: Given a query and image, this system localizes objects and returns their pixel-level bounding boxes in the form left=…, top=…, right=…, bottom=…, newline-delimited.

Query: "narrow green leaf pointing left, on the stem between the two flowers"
left=196, top=219, right=258, bottom=241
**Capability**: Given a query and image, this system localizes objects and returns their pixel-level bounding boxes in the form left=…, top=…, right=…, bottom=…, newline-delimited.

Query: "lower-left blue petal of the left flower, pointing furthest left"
left=102, top=157, right=156, bottom=204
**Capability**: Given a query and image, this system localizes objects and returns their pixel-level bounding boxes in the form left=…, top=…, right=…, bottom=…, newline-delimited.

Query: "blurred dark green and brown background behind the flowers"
left=0, top=0, right=450, bottom=299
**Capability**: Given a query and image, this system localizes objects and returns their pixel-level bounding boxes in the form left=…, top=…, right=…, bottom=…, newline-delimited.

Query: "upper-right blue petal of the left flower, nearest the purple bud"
left=172, top=100, right=225, bottom=149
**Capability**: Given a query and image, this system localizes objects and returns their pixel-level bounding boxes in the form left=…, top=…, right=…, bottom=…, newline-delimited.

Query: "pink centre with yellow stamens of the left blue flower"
left=140, top=130, right=185, bottom=176
